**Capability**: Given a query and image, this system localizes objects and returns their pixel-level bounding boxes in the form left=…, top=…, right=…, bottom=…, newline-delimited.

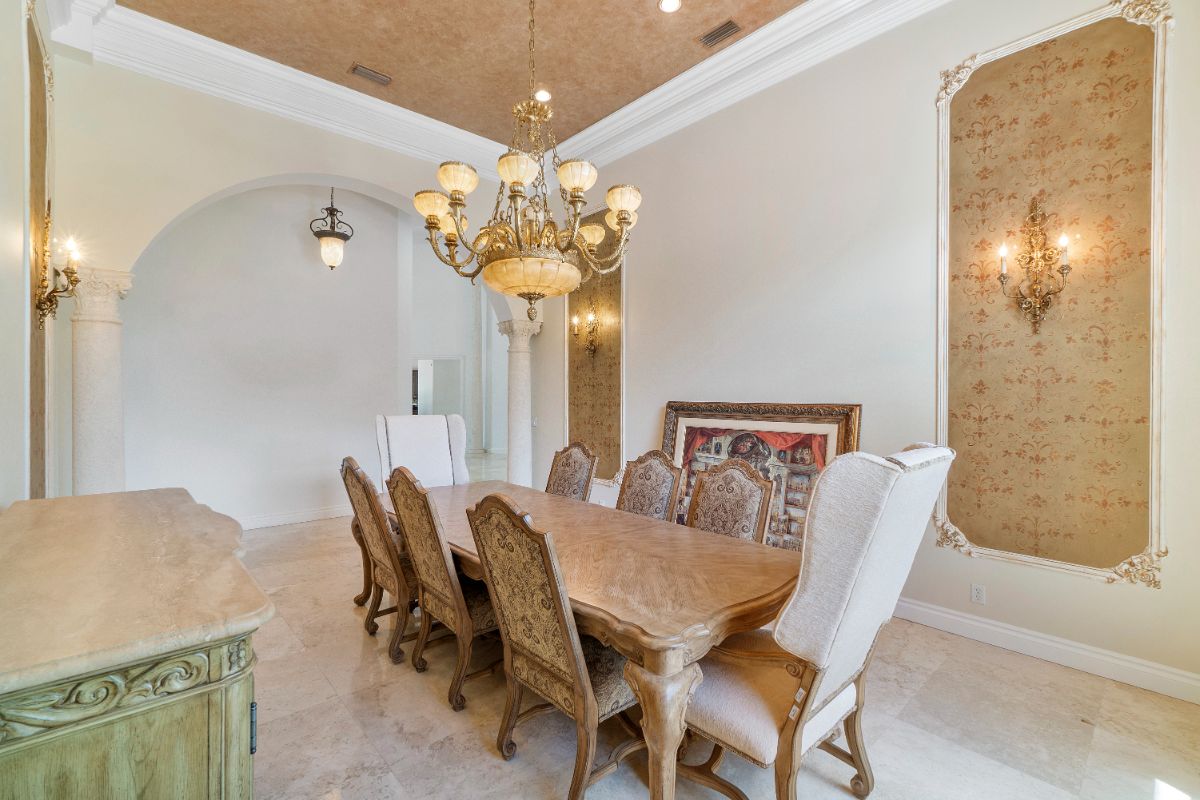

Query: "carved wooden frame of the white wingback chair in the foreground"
left=678, top=626, right=883, bottom=800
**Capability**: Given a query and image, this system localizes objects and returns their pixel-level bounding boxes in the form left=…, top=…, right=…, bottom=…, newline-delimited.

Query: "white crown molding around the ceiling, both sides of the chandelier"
left=46, top=0, right=949, bottom=173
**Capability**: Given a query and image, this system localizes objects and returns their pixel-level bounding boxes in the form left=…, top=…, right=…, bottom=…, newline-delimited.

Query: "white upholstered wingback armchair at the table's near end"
left=679, top=444, right=954, bottom=800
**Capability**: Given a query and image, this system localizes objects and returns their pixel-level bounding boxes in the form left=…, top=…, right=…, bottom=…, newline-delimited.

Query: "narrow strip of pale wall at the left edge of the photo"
left=0, top=2, right=30, bottom=509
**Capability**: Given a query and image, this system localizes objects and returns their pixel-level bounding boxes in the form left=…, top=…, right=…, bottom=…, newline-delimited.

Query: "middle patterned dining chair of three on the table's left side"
left=388, top=467, right=497, bottom=711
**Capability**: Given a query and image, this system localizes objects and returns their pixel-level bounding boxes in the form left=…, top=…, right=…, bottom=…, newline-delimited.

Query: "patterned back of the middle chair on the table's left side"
left=388, top=467, right=467, bottom=624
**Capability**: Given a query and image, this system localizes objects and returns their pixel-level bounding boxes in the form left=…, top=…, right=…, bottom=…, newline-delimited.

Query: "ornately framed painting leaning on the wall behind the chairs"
left=662, top=402, right=862, bottom=549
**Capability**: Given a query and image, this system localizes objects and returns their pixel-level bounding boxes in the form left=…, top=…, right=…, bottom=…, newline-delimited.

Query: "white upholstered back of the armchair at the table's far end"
left=376, top=414, right=470, bottom=486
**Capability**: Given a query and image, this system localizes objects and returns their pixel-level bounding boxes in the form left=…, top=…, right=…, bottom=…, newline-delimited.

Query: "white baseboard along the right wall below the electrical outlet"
left=895, top=597, right=1200, bottom=703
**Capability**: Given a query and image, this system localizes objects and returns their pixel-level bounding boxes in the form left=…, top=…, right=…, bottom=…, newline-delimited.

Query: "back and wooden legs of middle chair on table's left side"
left=388, top=467, right=502, bottom=711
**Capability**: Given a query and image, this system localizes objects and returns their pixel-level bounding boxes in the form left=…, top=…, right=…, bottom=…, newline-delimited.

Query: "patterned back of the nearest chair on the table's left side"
left=467, top=494, right=594, bottom=716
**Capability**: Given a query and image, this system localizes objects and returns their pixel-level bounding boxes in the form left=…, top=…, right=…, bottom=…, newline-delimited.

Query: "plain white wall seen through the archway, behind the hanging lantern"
left=121, top=186, right=412, bottom=528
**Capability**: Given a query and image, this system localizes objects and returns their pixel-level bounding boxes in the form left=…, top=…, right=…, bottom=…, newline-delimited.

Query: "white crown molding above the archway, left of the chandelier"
left=47, top=0, right=505, bottom=181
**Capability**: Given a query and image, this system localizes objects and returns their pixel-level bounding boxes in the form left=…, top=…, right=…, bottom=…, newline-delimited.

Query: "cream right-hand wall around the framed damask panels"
left=535, top=0, right=1200, bottom=691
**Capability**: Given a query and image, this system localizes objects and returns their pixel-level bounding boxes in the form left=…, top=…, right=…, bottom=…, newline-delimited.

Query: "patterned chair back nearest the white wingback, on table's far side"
left=688, top=458, right=775, bottom=542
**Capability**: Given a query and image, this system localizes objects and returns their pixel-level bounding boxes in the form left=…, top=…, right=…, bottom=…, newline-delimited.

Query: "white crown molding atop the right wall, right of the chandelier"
left=559, top=0, right=949, bottom=166
